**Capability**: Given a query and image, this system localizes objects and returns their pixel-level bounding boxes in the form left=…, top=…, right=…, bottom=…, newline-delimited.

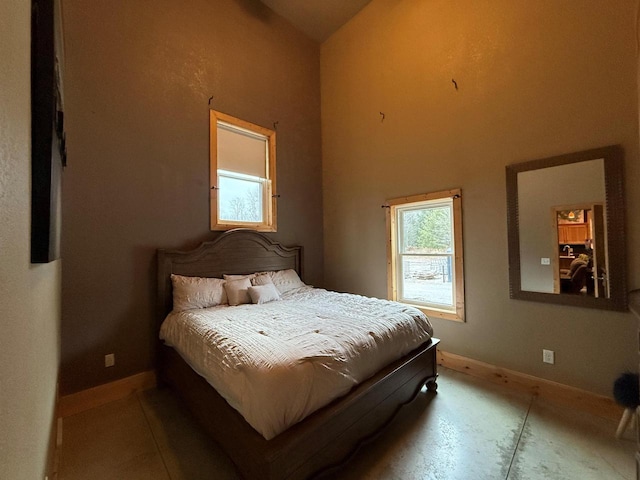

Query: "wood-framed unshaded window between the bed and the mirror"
left=387, top=189, right=464, bottom=321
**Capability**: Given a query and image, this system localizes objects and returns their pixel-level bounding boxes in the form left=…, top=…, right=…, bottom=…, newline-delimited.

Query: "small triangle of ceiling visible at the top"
left=261, top=0, right=371, bottom=42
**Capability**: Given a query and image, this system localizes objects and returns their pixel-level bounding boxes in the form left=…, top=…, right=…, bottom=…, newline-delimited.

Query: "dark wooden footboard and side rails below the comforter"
left=160, top=339, right=439, bottom=480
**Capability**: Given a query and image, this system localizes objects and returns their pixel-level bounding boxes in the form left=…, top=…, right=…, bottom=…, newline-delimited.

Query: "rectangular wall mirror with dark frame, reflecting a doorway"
left=507, top=146, right=627, bottom=310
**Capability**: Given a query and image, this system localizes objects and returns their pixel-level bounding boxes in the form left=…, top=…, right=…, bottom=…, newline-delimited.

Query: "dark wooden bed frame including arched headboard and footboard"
left=158, top=230, right=439, bottom=480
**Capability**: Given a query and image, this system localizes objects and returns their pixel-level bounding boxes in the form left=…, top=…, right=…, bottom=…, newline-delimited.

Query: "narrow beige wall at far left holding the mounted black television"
left=0, top=0, right=60, bottom=480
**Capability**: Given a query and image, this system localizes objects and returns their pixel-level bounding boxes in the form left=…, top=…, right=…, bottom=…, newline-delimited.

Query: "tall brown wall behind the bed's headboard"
left=61, top=0, right=323, bottom=393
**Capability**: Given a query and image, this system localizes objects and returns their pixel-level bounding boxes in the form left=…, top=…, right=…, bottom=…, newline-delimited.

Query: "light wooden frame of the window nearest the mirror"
left=386, top=189, right=465, bottom=322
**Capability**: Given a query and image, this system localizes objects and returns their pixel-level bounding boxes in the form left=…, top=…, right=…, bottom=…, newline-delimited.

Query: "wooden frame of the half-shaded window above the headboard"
left=209, top=110, right=278, bottom=232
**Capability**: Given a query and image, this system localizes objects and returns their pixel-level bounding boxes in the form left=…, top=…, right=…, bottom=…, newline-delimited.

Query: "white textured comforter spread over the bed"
left=160, top=287, right=433, bottom=440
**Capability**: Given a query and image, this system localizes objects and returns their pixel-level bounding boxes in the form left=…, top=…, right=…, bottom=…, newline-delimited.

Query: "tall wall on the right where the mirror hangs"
left=321, top=0, right=640, bottom=394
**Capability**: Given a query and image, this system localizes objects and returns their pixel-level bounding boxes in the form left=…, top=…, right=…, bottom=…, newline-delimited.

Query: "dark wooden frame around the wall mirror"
left=506, top=145, right=628, bottom=311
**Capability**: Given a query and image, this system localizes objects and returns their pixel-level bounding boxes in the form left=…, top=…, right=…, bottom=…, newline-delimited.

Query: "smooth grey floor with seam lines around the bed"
left=59, top=368, right=635, bottom=480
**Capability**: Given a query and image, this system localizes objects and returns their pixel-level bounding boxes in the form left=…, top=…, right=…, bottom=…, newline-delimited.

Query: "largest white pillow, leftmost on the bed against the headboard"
left=171, top=274, right=227, bottom=312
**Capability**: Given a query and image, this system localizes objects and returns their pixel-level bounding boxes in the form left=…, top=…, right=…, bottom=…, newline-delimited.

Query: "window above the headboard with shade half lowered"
left=210, top=110, right=276, bottom=232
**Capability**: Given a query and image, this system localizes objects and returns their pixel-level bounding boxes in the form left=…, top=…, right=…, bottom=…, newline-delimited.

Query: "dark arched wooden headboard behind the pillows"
left=158, top=229, right=303, bottom=325
